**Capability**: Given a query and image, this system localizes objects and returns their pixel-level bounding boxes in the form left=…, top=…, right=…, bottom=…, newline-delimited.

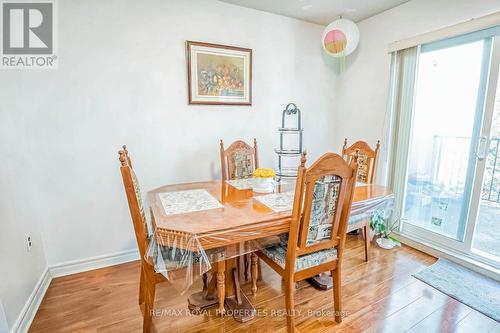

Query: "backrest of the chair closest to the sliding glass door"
left=342, top=138, right=380, bottom=184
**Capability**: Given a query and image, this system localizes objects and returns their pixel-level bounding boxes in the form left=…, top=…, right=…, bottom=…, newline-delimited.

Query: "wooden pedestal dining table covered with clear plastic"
left=147, top=179, right=394, bottom=322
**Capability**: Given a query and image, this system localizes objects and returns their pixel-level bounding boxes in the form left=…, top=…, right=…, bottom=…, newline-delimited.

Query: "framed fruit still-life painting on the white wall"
left=187, top=41, right=252, bottom=105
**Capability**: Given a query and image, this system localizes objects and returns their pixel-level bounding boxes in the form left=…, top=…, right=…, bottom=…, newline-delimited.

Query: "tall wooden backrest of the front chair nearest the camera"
left=287, top=153, right=357, bottom=262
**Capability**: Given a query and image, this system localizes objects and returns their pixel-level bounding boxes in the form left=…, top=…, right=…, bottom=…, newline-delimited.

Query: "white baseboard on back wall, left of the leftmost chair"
left=49, top=249, right=139, bottom=277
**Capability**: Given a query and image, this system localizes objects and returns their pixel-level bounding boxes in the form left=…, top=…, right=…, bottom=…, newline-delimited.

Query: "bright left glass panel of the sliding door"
left=403, top=40, right=488, bottom=242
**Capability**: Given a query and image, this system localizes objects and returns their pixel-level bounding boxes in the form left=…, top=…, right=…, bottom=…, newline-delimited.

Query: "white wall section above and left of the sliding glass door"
left=334, top=0, right=500, bottom=182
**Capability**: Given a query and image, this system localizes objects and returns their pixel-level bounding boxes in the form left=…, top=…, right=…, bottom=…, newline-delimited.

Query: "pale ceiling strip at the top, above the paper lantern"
left=220, top=0, right=409, bottom=25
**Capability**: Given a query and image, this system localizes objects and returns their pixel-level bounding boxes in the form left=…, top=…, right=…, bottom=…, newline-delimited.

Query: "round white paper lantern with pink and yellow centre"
left=321, top=19, right=359, bottom=58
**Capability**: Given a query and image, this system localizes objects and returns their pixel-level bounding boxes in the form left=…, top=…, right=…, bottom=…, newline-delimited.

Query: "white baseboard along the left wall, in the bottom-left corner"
left=11, top=267, right=52, bottom=333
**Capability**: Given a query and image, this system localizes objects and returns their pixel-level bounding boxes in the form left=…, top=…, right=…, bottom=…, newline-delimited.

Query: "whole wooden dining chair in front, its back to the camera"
left=252, top=153, right=357, bottom=332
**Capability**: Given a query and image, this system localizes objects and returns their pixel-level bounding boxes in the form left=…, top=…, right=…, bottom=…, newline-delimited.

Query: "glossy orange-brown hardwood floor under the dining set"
left=30, top=236, right=500, bottom=333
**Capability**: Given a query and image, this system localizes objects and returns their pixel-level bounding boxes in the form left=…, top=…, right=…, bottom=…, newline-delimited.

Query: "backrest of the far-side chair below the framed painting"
left=220, top=139, right=259, bottom=181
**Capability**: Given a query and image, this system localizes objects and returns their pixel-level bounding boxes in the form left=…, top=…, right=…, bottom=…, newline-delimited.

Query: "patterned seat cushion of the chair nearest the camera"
left=261, top=237, right=337, bottom=272
